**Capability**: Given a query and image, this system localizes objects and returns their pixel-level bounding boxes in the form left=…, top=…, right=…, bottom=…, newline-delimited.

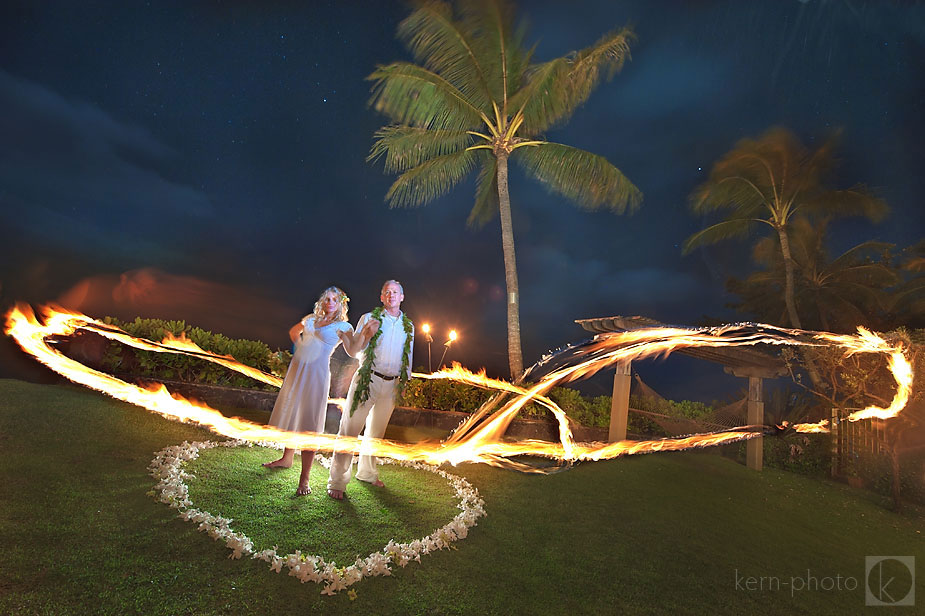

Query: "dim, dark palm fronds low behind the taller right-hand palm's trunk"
left=727, top=217, right=899, bottom=333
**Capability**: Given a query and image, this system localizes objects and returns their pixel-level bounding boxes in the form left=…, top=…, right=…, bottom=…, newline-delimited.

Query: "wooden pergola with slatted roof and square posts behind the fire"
left=575, top=316, right=787, bottom=471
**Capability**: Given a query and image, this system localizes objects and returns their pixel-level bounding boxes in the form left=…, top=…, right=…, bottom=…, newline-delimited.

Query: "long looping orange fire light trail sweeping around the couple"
left=5, top=304, right=913, bottom=473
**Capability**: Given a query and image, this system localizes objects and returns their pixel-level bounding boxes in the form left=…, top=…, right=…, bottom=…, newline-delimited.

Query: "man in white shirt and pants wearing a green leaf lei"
left=328, top=280, right=414, bottom=500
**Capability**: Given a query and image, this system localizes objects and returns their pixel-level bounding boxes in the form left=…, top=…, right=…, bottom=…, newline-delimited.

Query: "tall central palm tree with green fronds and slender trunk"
left=368, top=0, right=642, bottom=379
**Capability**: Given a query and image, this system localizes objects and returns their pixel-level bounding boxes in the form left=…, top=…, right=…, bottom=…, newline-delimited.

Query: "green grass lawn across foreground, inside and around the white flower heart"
left=0, top=380, right=925, bottom=615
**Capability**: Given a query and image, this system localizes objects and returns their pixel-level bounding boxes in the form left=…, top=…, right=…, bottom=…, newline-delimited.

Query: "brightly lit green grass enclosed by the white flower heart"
left=186, top=447, right=459, bottom=568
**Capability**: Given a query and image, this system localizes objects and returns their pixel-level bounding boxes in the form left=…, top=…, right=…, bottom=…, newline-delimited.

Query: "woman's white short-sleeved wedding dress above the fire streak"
left=269, top=315, right=353, bottom=433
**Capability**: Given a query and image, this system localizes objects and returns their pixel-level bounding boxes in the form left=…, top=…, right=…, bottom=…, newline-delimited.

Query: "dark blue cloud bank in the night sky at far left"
left=0, top=71, right=215, bottom=224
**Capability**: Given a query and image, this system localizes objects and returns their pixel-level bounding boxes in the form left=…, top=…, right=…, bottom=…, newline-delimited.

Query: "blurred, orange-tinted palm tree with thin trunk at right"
left=683, top=128, right=888, bottom=328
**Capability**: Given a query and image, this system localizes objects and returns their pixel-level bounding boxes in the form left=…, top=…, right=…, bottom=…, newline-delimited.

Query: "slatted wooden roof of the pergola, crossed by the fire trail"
left=575, top=316, right=787, bottom=378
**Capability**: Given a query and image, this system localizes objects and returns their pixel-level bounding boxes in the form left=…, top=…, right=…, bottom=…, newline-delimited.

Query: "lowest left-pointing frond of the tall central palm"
left=385, top=150, right=478, bottom=207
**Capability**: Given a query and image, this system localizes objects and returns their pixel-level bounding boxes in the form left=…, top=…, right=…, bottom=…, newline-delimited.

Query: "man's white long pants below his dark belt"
left=328, top=374, right=398, bottom=491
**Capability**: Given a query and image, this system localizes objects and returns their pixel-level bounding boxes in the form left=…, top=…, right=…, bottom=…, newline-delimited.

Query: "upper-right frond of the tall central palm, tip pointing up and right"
left=511, top=28, right=636, bottom=135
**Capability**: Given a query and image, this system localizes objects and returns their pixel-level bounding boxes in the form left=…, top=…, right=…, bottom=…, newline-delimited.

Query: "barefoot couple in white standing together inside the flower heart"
left=264, top=280, right=414, bottom=500
